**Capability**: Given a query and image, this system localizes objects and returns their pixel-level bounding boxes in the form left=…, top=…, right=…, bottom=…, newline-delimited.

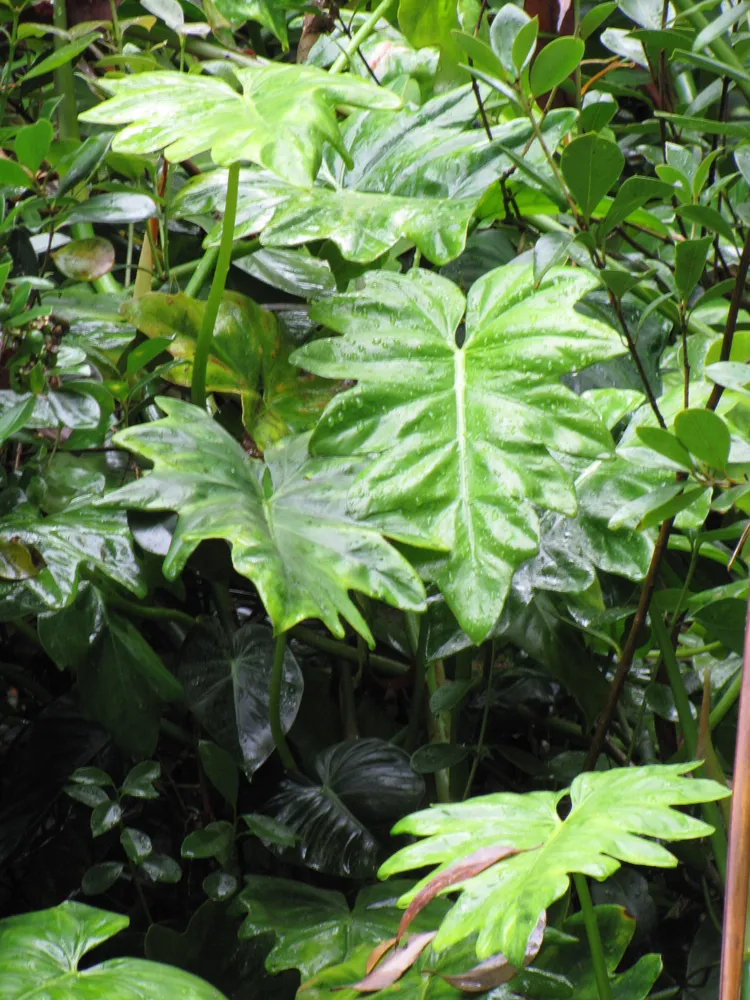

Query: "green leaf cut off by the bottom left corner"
left=0, top=901, right=229, bottom=1000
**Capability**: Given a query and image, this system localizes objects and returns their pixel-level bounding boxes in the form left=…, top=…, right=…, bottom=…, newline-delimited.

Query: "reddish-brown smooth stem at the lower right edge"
left=719, top=602, right=750, bottom=1000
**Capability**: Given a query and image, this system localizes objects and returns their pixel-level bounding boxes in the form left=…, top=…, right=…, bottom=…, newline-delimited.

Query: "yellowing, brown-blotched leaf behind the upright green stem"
left=121, top=292, right=337, bottom=449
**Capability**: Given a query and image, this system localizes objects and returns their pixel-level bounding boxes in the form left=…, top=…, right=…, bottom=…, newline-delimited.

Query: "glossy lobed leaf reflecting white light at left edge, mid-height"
left=0, top=505, right=146, bottom=621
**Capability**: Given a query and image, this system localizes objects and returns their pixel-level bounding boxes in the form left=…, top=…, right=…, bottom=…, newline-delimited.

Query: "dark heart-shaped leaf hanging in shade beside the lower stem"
left=179, top=621, right=303, bottom=776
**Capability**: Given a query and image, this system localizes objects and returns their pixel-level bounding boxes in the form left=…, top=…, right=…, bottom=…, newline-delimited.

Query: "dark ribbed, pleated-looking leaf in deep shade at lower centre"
left=265, top=739, right=424, bottom=878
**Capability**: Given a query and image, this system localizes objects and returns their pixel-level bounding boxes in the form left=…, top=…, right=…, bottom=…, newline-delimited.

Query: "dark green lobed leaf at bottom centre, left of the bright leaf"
left=240, top=875, right=447, bottom=980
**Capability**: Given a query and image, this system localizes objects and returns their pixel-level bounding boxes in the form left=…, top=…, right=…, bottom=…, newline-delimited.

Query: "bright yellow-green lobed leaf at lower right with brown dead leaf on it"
left=380, top=763, right=729, bottom=966
